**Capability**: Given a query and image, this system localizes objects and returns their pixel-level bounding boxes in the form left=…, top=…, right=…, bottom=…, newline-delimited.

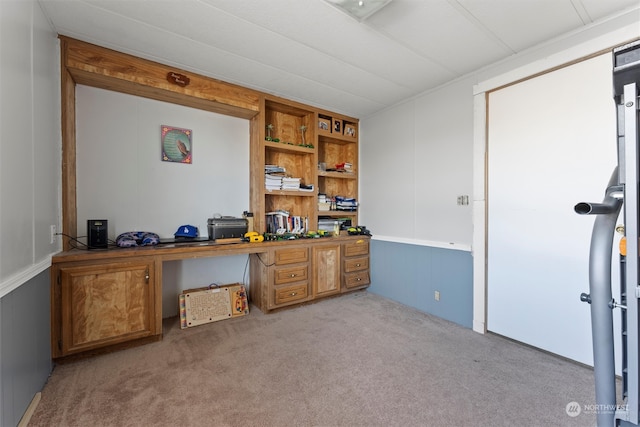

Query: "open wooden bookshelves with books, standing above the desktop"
left=250, top=95, right=358, bottom=237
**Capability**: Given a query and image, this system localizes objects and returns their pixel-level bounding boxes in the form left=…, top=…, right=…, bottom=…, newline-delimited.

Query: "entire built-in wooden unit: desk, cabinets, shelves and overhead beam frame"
left=51, top=37, right=370, bottom=359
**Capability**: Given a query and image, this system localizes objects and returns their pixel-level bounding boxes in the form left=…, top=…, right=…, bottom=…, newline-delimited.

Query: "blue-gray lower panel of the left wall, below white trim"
left=0, top=269, right=52, bottom=427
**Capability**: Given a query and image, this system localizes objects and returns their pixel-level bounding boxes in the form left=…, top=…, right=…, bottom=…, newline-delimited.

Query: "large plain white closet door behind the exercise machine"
left=487, top=54, right=620, bottom=364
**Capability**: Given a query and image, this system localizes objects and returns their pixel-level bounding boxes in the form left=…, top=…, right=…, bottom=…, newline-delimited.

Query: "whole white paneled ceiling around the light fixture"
left=37, top=0, right=640, bottom=117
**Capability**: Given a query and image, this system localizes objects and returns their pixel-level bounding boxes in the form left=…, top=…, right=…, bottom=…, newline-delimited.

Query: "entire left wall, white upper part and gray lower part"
left=0, top=0, right=61, bottom=426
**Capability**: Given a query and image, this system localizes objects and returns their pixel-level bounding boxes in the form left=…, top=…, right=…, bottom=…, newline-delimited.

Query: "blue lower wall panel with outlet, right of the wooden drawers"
left=369, top=238, right=473, bottom=328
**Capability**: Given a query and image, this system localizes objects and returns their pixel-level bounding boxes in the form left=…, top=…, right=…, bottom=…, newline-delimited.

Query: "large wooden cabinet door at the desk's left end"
left=60, top=262, right=155, bottom=355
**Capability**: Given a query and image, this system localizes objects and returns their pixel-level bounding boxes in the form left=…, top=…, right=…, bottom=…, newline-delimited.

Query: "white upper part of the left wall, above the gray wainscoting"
left=0, top=1, right=61, bottom=297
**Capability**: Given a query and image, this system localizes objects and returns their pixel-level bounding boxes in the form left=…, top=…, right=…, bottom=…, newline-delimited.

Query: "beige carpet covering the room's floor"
left=29, top=291, right=595, bottom=427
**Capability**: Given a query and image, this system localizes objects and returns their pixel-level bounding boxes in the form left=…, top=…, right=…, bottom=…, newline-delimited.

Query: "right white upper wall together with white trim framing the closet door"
left=360, top=8, right=640, bottom=364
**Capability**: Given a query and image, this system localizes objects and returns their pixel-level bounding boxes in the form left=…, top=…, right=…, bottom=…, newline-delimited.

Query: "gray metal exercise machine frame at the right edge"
left=575, top=40, right=640, bottom=427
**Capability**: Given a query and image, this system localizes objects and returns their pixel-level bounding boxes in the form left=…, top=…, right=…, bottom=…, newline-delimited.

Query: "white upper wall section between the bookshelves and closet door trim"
left=360, top=75, right=475, bottom=250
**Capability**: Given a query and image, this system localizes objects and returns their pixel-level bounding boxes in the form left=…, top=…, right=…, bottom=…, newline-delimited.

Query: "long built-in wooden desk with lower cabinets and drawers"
left=51, top=236, right=370, bottom=360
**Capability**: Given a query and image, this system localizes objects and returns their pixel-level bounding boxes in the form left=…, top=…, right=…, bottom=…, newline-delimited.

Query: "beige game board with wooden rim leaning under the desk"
left=179, top=283, right=249, bottom=329
